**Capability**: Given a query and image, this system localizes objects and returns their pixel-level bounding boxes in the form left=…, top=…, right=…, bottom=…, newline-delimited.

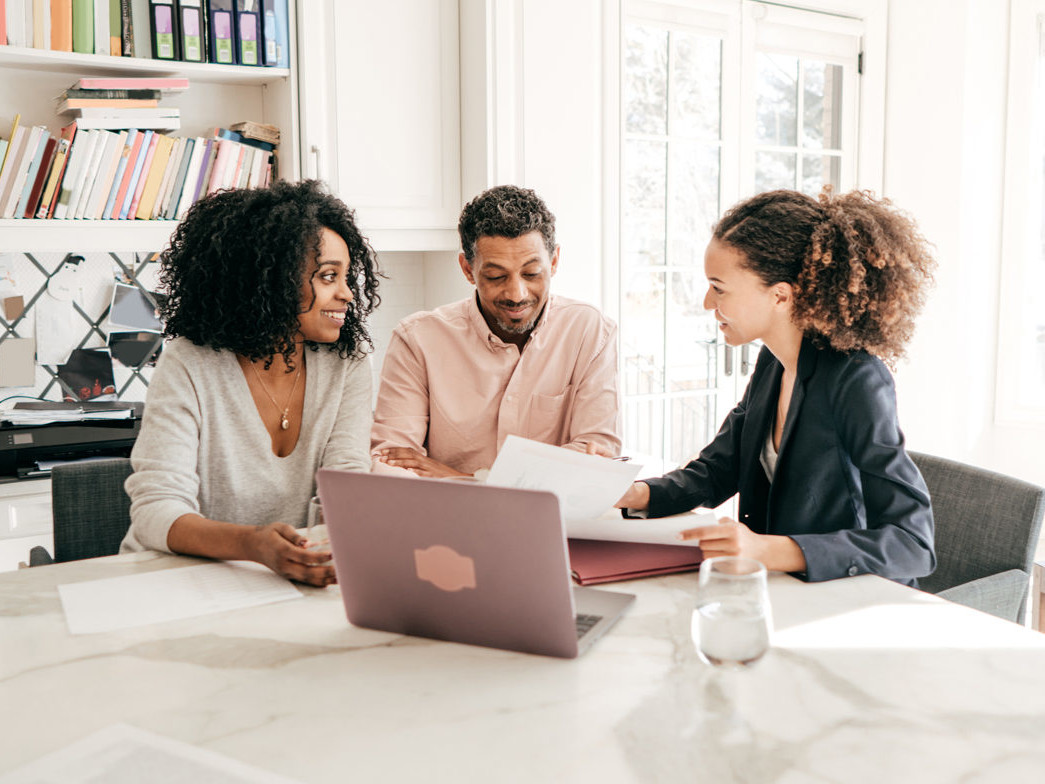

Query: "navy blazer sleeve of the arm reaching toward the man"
left=642, top=369, right=762, bottom=517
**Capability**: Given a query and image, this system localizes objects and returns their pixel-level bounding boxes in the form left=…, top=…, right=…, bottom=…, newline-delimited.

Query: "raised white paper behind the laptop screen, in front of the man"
left=486, top=436, right=642, bottom=523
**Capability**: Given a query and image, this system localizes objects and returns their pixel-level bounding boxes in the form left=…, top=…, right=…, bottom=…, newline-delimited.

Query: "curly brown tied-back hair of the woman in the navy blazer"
left=714, top=187, right=936, bottom=366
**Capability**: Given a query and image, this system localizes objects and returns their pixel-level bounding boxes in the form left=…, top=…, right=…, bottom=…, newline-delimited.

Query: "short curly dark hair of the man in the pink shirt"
left=458, top=185, right=555, bottom=262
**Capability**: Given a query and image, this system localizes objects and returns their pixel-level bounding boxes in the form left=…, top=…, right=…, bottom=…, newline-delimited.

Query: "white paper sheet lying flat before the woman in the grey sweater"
left=59, top=561, right=301, bottom=635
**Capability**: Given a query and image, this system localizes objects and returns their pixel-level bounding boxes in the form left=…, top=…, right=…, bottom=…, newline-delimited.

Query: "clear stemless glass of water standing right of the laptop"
left=692, top=556, right=772, bottom=669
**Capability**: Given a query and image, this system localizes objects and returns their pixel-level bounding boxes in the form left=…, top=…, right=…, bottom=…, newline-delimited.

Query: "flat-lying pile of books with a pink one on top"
left=57, top=77, right=189, bottom=131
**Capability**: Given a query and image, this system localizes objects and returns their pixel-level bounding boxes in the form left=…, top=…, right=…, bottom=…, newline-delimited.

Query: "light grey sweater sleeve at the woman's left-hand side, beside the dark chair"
left=120, top=350, right=201, bottom=552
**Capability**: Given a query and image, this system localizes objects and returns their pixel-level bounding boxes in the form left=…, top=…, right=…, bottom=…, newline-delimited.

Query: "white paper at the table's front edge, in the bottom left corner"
left=0, top=724, right=303, bottom=784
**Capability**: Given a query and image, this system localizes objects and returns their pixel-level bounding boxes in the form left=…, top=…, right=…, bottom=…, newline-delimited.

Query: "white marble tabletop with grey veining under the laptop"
left=0, top=553, right=1045, bottom=784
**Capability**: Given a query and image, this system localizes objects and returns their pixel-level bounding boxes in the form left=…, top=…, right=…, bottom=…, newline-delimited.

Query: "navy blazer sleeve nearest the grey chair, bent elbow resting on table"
left=791, top=361, right=936, bottom=581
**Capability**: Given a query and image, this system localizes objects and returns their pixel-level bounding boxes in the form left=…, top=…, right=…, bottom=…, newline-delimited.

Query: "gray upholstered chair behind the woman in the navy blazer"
left=910, top=452, right=1045, bottom=623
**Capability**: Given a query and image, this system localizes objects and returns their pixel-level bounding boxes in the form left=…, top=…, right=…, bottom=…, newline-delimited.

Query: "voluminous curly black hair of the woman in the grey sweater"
left=160, top=180, right=381, bottom=367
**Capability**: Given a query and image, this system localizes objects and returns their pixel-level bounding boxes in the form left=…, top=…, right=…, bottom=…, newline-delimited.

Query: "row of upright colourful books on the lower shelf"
left=0, top=107, right=276, bottom=220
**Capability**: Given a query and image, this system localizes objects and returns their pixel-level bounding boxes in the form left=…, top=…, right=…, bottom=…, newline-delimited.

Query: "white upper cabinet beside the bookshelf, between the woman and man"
left=298, top=0, right=461, bottom=251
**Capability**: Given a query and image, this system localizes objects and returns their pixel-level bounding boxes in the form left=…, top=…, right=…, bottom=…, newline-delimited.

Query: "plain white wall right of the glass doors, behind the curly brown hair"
left=883, top=0, right=1045, bottom=483
